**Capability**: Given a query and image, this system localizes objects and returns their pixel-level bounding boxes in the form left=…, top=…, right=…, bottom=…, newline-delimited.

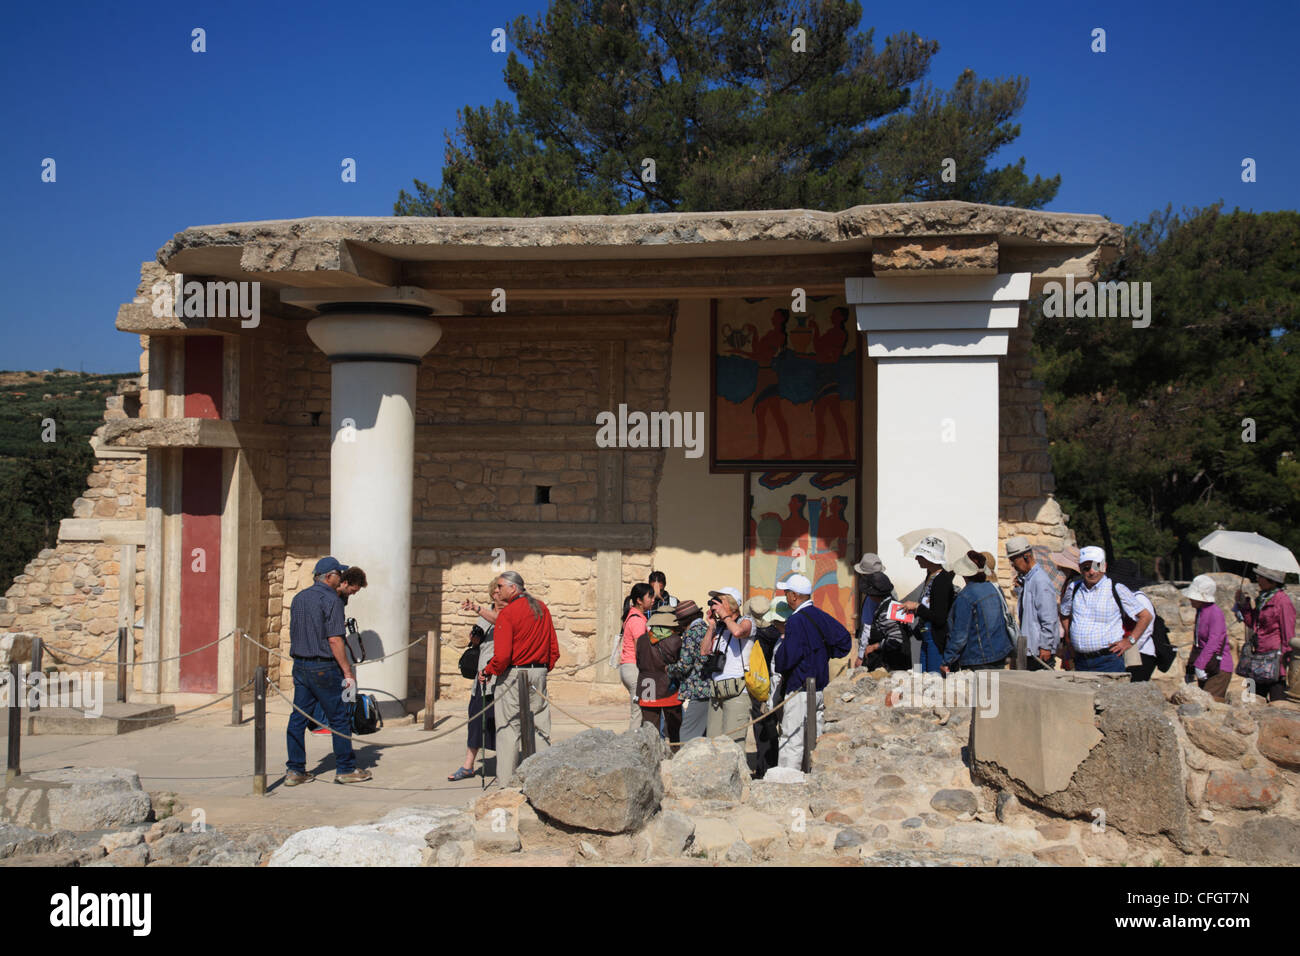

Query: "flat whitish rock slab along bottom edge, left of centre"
left=267, top=806, right=465, bottom=866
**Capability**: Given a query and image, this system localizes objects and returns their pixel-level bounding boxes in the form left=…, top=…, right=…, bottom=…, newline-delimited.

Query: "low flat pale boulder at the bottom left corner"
left=0, top=767, right=153, bottom=830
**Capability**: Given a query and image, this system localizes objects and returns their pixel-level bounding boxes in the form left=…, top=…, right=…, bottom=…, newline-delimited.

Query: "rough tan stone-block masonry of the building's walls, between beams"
left=0, top=317, right=1074, bottom=687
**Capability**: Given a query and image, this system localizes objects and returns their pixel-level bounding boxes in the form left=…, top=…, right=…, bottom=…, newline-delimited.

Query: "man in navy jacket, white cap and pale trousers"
left=772, top=575, right=853, bottom=770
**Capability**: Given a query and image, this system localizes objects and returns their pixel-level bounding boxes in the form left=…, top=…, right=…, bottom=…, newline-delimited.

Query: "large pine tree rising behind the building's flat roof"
left=394, top=0, right=1061, bottom=216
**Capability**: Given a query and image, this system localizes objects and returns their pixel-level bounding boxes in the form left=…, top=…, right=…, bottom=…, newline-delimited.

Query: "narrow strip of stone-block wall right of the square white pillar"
left=996, top=317, right=1075, bottom=593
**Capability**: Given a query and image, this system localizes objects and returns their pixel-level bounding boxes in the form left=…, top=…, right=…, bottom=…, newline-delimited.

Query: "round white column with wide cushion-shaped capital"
left=307, top=304, right=442, bottom=717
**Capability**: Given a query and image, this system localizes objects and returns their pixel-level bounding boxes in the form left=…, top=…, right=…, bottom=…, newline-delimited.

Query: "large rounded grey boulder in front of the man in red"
left=511, top=724, right=666, bottom=834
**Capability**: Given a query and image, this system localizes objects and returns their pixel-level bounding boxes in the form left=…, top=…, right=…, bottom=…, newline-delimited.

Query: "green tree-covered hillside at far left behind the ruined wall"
left=0, top=369, right=127, bottom=591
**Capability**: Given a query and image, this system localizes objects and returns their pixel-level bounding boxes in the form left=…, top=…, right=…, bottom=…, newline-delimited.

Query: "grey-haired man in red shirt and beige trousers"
left=478, top=571, right=560, bottom=784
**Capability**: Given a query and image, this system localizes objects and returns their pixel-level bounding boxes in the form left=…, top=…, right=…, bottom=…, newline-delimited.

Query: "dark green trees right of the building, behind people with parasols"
left=1031, top=206, right=1300, bottom=576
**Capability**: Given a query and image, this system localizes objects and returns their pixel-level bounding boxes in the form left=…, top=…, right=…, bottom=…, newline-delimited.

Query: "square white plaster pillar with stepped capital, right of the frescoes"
left=845, top=272, right=1031, bottom=594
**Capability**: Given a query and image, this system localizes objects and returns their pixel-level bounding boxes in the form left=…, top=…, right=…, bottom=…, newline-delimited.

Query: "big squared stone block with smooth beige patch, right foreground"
left=971, top=672, right=1196, bottom=852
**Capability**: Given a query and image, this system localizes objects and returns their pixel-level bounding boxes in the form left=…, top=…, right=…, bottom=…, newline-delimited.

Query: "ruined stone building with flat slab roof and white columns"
left=0, top=203, right=1122, bottom=702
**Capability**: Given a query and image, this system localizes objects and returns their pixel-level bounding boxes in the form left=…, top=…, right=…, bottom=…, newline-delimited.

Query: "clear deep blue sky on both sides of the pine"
left=0, top=0, right=1300, bottom=372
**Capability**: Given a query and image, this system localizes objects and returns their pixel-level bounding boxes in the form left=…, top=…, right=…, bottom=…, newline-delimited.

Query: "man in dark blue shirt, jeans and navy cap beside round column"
left=285, top=558, right=371, bottom=787
